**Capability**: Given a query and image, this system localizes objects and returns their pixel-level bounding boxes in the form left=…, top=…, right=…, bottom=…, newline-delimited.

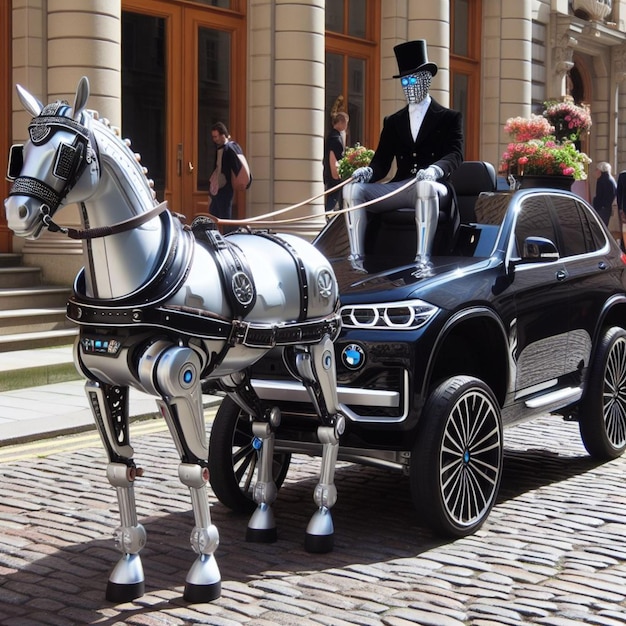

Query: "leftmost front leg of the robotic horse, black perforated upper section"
left=85, top=380, right=146, bottom=603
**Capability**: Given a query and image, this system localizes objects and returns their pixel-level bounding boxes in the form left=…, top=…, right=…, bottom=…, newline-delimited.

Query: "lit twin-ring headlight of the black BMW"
left=341, top=300, right=439, bottom=330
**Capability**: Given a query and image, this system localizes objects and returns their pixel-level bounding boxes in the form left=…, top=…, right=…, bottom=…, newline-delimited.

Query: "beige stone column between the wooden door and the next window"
left=249, top=0, right=325, bottom=237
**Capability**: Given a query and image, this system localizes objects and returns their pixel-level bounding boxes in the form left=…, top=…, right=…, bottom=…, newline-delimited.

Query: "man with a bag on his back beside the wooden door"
left=209, top=122, right=252, bottom=219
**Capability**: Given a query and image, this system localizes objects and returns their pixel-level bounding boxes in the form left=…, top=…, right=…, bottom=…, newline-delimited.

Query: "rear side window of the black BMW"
left=551, top=196, right=605, bottom=257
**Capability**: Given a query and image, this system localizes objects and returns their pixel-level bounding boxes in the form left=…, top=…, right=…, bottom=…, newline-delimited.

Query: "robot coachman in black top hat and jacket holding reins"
left=347, top=39, right=463, bottom=259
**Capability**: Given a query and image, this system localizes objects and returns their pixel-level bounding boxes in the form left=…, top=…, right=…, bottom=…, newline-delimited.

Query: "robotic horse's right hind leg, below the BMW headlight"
left=295, top=335, right=345, bottom=553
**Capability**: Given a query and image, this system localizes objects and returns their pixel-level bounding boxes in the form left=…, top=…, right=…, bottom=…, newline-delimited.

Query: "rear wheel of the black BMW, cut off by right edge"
left=578, top=327, right=626, bottom=461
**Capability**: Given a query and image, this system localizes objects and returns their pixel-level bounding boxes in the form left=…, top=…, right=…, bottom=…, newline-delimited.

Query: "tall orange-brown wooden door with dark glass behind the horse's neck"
left=122, top=0, right=246, bottom=221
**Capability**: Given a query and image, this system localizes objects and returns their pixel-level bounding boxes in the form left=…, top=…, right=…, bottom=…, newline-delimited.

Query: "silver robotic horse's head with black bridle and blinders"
left=4, top=77, right=100, bottom=239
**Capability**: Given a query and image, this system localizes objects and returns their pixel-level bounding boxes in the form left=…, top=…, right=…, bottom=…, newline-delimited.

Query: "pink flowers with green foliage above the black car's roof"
left=501, top=99, right=591, bottom=180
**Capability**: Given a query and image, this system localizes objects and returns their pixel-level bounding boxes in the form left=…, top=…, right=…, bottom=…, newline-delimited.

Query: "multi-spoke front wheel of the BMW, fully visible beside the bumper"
left=410, top=376, right=503, bottom=537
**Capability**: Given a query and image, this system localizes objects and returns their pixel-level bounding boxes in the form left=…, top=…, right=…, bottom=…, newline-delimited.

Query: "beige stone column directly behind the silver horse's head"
left=22, top=0, right=122, bottom=283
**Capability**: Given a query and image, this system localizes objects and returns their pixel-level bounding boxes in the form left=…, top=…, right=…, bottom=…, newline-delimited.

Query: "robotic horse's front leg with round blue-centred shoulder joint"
left=139, top=344, right=221, bottom=603
